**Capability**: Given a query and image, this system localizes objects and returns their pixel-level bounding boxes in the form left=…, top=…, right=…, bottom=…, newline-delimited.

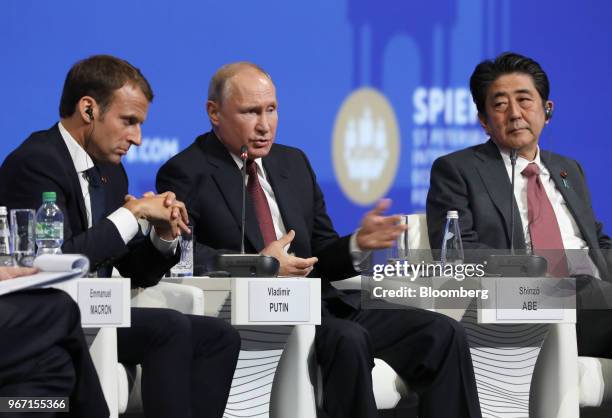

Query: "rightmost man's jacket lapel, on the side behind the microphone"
left=476, top=139, right=525, bottom=249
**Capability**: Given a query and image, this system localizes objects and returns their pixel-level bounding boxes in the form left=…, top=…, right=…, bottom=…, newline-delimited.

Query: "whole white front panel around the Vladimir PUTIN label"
left=232, top=278, right=321, bottom=325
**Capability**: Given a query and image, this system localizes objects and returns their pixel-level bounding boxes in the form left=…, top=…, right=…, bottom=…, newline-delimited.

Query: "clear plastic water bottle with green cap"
left=36, top=192, right=64, bottom=256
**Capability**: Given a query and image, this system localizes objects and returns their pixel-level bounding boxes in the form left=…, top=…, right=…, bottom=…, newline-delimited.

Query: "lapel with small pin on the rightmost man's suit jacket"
left=540, top=151, right=599, bottom=248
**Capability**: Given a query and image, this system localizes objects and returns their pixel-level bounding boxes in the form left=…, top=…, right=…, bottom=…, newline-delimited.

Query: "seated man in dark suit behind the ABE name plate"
left=427, top=53, right=612, bottom=357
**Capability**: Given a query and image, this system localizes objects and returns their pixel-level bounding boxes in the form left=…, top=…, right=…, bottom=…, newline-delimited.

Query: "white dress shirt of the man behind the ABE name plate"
left=498, top=147, right=599, bottom=277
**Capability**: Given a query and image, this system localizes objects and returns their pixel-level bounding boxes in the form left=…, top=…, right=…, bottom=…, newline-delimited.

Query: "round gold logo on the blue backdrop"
left=332, top=88, right=400, bottom=205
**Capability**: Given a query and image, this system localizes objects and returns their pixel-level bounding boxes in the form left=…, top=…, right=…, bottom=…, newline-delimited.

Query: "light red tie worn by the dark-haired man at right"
left=521, top=163, right=568, bottom=277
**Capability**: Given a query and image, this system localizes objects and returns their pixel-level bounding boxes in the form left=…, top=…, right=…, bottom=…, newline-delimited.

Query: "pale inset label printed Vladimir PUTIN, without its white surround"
left=249, top=281, right=310, bottom=322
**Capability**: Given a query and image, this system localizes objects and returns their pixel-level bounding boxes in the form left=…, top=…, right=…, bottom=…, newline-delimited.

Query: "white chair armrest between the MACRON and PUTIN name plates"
left=132, top=282, right=204, bottom=315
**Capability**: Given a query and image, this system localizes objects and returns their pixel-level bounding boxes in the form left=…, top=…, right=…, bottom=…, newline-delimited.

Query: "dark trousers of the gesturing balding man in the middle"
left=316, top=293, right=481, bottom=418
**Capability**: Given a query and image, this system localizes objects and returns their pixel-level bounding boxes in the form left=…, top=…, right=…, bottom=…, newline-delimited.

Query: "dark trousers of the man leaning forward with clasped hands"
left=117, top=308, right=240, bottom=418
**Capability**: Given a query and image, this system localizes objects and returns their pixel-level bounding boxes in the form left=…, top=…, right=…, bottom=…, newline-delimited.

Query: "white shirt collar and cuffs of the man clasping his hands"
left=58, top=122, right=178, bottom=255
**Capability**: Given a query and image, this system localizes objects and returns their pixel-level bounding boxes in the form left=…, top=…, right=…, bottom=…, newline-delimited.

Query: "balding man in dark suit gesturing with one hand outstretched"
left=157, top=62, right=480, bottom=418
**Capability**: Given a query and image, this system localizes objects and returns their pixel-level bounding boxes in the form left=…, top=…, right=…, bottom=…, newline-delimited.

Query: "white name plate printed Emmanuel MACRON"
left=77, top=279, right=130, bottom=327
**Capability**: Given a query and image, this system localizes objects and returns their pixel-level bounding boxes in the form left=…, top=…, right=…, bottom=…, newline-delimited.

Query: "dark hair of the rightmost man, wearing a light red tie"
left=470, top=52, right=550, bottom=115
